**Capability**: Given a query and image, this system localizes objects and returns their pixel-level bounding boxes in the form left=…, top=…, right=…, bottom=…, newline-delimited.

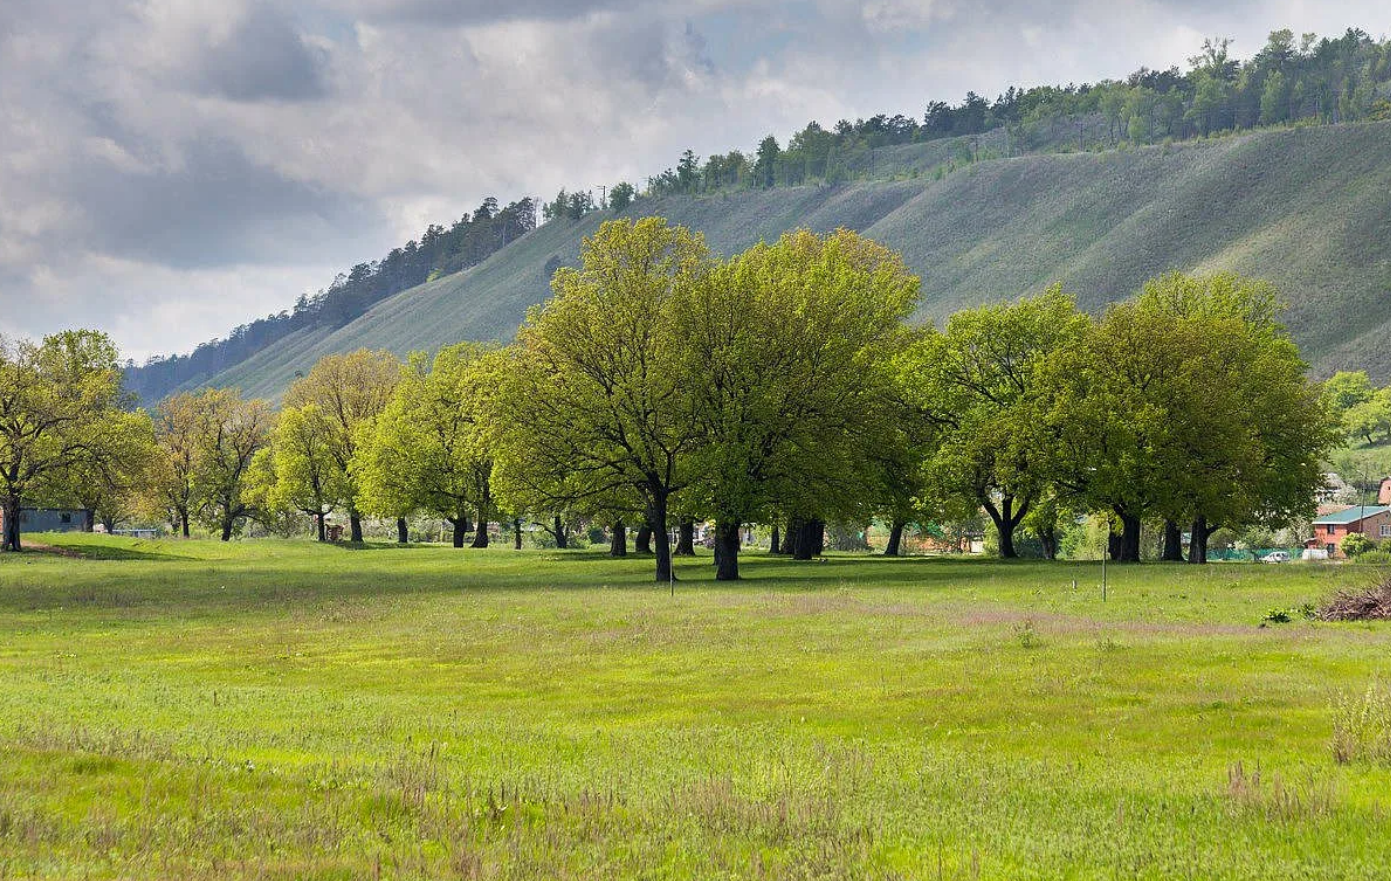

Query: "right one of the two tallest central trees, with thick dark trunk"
left=675, top=230, right=918, bottom=580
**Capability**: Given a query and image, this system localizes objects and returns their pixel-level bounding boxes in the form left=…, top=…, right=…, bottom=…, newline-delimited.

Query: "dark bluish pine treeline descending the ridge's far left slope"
left=125, top=196, right=536, bottom=401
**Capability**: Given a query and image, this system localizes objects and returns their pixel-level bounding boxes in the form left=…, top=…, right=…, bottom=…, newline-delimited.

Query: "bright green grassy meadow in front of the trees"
left=0, top=536, right=1391, bottom=878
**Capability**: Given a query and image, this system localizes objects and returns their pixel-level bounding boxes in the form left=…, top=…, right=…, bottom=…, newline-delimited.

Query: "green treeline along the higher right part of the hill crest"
left=609, top=29, right=1391, bottom=199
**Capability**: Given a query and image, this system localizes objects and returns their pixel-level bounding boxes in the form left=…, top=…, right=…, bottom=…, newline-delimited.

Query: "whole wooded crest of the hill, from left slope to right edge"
left=125, top=29, right=1391, bottom=401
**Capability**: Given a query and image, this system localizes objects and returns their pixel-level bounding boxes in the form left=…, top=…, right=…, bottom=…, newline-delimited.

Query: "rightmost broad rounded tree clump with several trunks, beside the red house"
left=1046, top=274, right=1335, bottom=562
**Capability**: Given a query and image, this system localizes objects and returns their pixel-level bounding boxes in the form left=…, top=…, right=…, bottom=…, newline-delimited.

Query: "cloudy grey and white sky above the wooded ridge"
left=0, top=0, right=1391, bottom=360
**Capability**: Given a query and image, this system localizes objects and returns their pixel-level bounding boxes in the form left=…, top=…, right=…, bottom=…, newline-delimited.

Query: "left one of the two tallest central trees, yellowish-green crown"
left=491, top=217, right=709, bottom=582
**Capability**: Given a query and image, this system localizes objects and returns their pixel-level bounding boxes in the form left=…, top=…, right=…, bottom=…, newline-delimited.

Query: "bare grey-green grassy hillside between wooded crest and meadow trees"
left=201, top=122, right=1391, bottom=398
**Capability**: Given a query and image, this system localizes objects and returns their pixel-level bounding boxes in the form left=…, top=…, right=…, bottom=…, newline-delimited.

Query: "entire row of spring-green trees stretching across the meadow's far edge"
left=0, top=217, right=1341, bottom=570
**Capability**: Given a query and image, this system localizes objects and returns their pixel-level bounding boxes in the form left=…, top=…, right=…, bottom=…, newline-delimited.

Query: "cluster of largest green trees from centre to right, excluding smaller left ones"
left=491, top=219, right=1338, bottom=579
